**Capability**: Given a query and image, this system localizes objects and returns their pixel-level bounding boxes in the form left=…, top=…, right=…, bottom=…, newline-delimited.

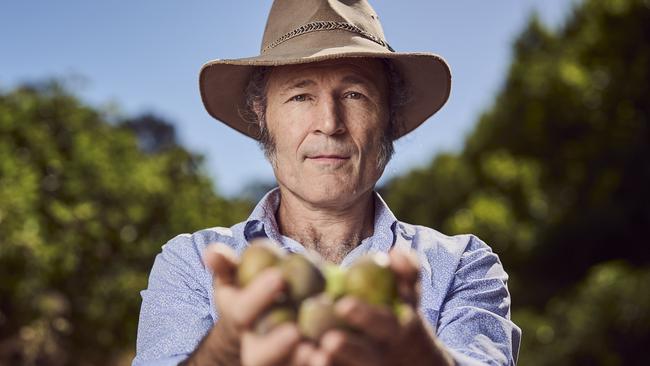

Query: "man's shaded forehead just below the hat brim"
left=271, top=58, right=386, bottom=87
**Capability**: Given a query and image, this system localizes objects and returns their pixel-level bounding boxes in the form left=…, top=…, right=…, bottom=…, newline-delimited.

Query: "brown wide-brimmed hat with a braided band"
left=199, top=0, right=451, bottom=139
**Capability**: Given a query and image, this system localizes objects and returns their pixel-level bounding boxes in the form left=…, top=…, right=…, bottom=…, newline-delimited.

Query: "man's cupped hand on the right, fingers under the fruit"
left=308, top=250, right=453, bottom=366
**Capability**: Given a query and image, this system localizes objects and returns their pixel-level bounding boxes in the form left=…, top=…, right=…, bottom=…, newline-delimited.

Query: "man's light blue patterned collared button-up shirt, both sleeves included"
left=133, top=189, right=521, bottom=365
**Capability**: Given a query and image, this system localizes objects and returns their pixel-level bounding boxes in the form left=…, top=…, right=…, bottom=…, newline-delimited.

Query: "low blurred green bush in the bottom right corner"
left=513, top=262, right=650, bottom=366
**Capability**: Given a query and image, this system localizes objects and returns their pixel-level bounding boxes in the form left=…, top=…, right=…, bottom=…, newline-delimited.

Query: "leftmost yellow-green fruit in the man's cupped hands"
left=237, top=240, right=282, bottom=287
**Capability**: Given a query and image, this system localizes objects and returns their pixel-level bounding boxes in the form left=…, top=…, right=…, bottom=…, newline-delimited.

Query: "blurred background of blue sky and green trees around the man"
left=0, top=0, right=650, bottom=365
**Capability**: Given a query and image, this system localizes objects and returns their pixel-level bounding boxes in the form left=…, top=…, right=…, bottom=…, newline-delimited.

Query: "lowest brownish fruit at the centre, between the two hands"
left=298, top=293, right=343, bottom=341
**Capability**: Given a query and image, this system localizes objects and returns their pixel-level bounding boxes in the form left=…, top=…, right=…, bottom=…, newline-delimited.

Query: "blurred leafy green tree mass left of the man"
left=0, top=83, right=250, bottom=365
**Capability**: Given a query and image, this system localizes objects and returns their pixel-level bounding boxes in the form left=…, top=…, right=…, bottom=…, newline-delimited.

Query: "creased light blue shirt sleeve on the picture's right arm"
left=437, top=236, right=521, bottom=365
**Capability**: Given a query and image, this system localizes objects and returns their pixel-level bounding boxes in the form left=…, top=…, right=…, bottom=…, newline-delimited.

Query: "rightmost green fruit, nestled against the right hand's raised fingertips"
left=345, top=252, right=397, bottom=306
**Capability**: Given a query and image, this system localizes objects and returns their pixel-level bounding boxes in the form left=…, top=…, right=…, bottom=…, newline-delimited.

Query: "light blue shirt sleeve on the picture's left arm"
left=133, top=235, right=214, bottom=366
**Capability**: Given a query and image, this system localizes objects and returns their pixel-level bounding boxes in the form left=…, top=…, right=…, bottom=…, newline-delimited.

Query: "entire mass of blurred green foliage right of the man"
left=385, top=0, right=650, bottom=365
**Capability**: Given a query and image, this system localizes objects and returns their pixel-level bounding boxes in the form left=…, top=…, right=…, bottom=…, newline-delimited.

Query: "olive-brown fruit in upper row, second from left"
left=279, top=253, right=325, bottom=304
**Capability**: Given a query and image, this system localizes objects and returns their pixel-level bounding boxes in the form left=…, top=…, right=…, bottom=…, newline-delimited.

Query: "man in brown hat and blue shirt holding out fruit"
left=134, top=0, right=520, bottom=366
